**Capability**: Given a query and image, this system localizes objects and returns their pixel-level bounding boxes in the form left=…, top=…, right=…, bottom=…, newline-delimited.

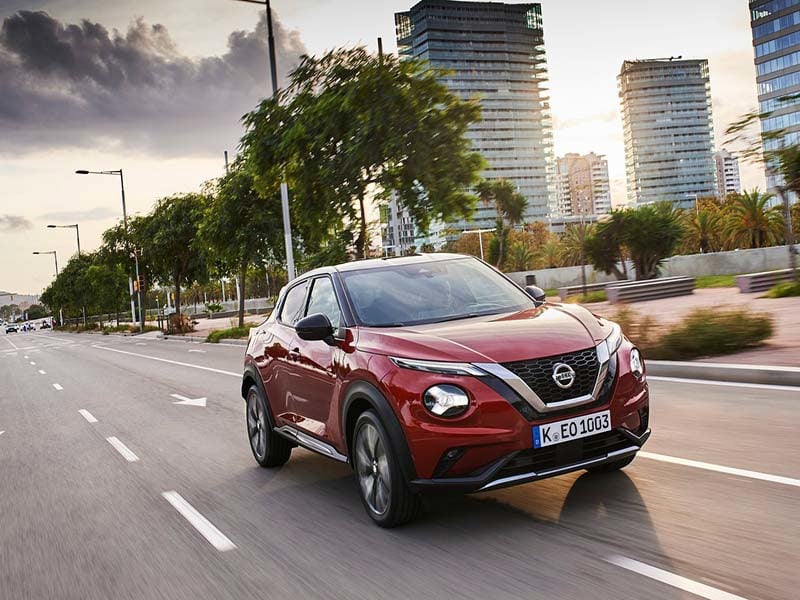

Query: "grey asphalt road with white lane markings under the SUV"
left=0, top=333, right=800, bottom=600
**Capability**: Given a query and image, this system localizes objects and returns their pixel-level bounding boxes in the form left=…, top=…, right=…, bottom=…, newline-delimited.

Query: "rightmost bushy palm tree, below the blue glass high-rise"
left=725, top=189, right=783, bottom=248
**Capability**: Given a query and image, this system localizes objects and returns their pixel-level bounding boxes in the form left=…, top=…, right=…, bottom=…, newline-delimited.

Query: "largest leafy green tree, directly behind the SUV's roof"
left=242, top=48, right=483, bottom=258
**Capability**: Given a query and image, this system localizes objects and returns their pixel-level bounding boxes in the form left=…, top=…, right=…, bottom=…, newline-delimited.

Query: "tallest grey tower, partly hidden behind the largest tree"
left=395, top=0, right=556, bottom=229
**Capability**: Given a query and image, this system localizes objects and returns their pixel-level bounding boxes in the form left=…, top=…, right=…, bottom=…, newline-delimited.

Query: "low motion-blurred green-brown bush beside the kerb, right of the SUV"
left=614, top=308, right=773, bottom=360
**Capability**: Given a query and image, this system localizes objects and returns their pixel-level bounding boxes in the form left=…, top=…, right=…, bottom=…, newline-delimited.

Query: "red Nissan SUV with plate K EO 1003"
left=242, top=254, right=650, bottom=527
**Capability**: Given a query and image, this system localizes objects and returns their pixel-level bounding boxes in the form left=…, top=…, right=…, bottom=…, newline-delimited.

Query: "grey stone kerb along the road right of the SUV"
left=647, top=360, right=800, bottom=387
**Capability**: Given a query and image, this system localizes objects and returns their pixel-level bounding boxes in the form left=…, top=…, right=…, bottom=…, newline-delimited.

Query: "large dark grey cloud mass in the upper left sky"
left=0, top=10, right=306, bottom=156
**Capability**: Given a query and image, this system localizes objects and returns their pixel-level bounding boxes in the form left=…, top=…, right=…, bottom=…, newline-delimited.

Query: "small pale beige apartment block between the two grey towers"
left=556, top=152, right=611, bottom=217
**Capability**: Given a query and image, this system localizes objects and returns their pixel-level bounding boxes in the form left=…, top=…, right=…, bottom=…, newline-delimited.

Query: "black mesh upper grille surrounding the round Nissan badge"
left=503, top=348, right=600, bottom=404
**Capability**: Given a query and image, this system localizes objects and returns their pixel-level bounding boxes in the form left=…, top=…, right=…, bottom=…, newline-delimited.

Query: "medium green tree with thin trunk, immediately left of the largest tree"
left=199, top=163, right=283, bottom=327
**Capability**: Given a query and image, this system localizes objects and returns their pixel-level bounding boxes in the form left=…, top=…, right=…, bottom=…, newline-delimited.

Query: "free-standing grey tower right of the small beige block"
left=618, top=58, right=717, bottom=206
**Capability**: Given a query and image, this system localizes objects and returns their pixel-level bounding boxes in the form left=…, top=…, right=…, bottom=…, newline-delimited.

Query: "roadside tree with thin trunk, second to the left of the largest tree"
left=136, top=193, right=209, bottom=322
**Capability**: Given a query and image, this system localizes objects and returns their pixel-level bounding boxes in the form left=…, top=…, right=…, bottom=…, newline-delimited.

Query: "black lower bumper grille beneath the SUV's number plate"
left=493, top=431, right=632, bottom=479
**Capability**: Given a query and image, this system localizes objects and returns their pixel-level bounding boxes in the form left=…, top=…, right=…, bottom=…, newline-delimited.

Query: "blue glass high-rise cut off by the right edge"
left=750, top=0, right=800, bottom=201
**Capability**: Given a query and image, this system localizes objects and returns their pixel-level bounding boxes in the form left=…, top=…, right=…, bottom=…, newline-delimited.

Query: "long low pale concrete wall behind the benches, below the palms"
left=507, top=246, right=800, bottom=289
